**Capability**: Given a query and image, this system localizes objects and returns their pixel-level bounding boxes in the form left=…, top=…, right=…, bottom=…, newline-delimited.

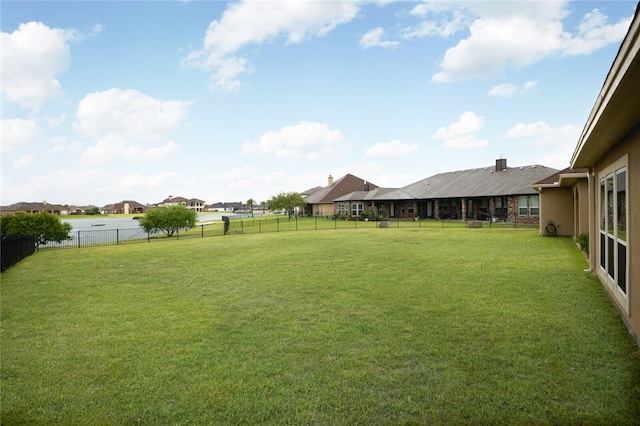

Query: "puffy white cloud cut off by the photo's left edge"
left=0, top=22, right=72, bottom=111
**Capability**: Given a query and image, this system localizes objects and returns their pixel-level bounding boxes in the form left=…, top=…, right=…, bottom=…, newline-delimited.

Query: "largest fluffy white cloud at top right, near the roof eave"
left=422, top=2, right=631, bottom=83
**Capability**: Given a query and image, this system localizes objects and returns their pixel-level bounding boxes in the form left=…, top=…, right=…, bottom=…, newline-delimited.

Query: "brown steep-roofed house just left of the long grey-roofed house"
left=304, top=174, right=379, bottom=217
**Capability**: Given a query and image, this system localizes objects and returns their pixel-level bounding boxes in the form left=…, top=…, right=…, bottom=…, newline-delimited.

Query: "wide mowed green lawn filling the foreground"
left=1, top=228, right=640, bottom=425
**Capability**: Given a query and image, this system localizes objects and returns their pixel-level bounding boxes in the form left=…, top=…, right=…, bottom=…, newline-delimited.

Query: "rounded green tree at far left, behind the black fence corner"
left=0, top=212, right=71, bottom=248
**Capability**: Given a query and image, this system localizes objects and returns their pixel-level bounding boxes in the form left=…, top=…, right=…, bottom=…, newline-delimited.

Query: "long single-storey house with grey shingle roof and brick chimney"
left=368, top=159, right=557, bottom=223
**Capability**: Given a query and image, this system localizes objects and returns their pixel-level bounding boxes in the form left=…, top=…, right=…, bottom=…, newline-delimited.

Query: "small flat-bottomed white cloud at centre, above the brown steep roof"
left=242, top=121, right=344, bottom=160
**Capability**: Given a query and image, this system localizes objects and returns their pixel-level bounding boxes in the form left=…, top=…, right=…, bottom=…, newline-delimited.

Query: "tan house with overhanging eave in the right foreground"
left=560, top=4, right=640, bottom=345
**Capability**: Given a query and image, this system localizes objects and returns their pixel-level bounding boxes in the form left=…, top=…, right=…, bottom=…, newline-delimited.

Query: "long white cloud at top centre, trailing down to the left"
left=182, top=0, right=358, bottom=91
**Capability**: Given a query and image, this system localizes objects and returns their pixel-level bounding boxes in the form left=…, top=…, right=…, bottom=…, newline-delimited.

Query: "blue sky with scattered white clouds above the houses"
left=0, top=0, right=636, bottom=206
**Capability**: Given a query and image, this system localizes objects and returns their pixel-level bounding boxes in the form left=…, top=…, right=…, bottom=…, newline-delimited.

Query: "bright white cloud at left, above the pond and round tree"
left=76, top=88, right=190, bottom=141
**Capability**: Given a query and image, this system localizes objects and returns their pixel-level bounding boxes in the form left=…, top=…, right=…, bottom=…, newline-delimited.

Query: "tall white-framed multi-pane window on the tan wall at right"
left=598, top=156, right=629, bottom=313
